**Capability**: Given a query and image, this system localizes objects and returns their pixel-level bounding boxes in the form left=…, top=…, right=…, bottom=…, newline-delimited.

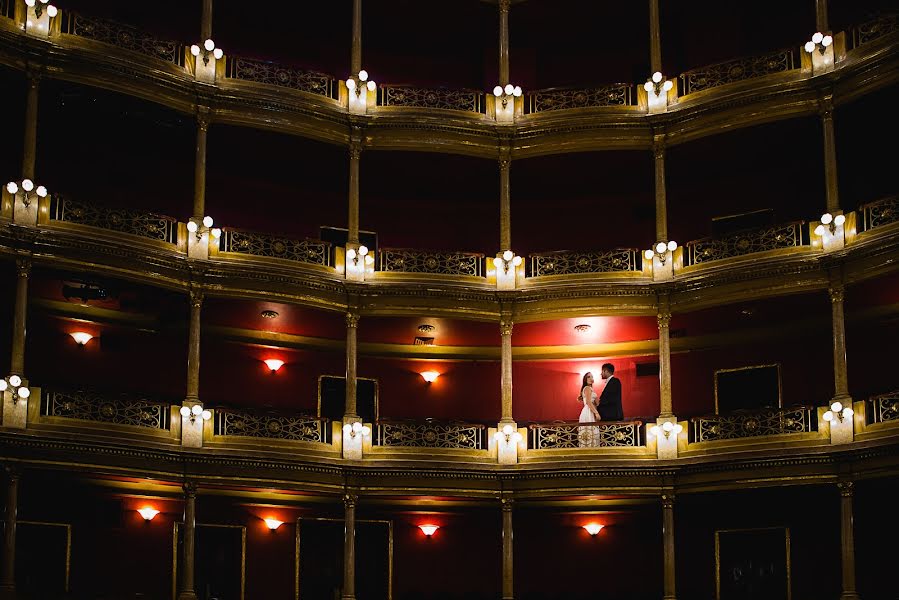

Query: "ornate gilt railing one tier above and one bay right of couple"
left=684, top=221, right=809, bottom=266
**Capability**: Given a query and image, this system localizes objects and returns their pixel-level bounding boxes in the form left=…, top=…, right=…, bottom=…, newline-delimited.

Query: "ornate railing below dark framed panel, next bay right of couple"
left=690, top=406, right=815, bottom=442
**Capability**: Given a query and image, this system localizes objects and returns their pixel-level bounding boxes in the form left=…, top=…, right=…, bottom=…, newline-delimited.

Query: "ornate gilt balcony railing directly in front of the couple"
left=528, top=421, right=644, bottom=450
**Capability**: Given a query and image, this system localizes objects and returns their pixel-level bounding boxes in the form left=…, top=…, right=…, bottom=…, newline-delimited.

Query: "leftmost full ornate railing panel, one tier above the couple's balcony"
left=50, top=195, right=178, bottom=244
